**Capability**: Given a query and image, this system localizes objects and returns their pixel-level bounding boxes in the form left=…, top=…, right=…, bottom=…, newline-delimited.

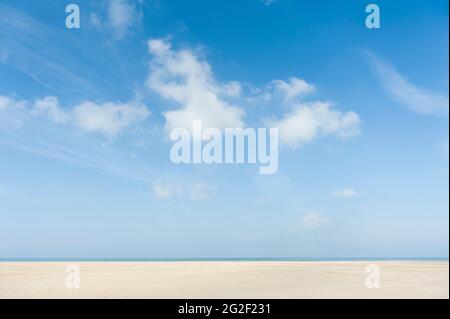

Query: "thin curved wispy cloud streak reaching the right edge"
left=369, top=53, right=449, bottom=116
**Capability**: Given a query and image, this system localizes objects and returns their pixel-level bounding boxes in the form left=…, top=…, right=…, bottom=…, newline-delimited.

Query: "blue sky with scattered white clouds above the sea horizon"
left=0, top=0, right=449, bottom=258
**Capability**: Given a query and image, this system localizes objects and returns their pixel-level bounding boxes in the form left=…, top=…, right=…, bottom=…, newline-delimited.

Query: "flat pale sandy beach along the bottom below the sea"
left=0, top=261, right=449, bottom=298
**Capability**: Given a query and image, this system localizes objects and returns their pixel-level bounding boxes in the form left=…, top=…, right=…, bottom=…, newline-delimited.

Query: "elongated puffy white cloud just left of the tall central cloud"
left=73, top=102, right=150, bottom=136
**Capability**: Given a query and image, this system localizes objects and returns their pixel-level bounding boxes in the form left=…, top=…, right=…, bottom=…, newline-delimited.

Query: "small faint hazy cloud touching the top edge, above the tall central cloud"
left=108, top=0, right=138, bottom=38
